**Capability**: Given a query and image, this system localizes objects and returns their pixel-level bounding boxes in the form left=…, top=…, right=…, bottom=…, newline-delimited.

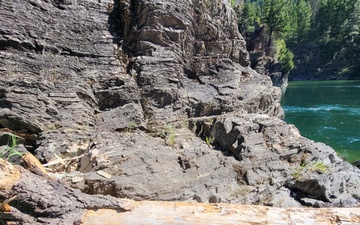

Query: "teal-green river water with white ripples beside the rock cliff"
left=282, top=81, right=360, bottom=162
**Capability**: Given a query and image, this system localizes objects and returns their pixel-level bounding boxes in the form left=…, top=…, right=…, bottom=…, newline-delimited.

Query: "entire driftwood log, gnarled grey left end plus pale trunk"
left=0, top=157, right=360, bottom=225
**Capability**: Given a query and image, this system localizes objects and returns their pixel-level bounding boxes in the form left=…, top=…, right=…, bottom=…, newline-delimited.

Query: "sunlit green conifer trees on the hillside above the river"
left=237, top=0, right=360, bottom=78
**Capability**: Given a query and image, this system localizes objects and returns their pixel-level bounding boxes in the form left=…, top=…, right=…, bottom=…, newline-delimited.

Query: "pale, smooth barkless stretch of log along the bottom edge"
left=82, top=201, right=360, bottom=225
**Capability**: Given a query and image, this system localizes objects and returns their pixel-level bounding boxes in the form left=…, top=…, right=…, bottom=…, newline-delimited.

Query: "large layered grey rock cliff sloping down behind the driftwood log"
left=0, top=0, right=360, bottom=211
